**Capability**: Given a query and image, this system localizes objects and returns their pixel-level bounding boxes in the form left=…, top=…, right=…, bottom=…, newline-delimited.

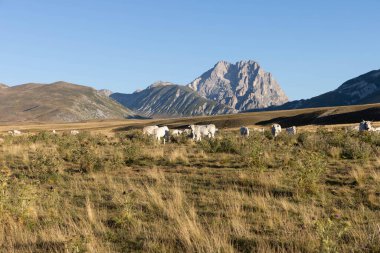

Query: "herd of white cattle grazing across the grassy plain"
left=0, top=120, right=380, bottom=144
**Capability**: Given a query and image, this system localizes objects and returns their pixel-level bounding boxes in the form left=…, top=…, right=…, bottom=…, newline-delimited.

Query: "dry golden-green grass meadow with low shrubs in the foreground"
left=0, top=127, right=380, bottom=253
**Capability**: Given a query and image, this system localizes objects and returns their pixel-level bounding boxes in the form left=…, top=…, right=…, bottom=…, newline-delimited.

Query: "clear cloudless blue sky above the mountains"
left=0, top=0, right=380, bottom=99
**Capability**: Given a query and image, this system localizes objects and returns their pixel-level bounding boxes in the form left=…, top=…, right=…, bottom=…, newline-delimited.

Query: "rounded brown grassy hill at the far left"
left=0, top=82, right=134, bottom=122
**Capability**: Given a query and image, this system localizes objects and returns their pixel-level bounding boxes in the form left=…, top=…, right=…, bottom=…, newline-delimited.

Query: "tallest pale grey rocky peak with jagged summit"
left=188, top=61, right=288, bottom=111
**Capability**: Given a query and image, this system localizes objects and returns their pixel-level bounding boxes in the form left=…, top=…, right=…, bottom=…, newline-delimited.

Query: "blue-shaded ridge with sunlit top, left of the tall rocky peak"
left=111, top=82, right=236, bottom=117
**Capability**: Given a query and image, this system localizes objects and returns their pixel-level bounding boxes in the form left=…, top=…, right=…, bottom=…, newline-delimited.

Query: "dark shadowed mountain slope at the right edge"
left=271, top=70, right=380, bottom=110
